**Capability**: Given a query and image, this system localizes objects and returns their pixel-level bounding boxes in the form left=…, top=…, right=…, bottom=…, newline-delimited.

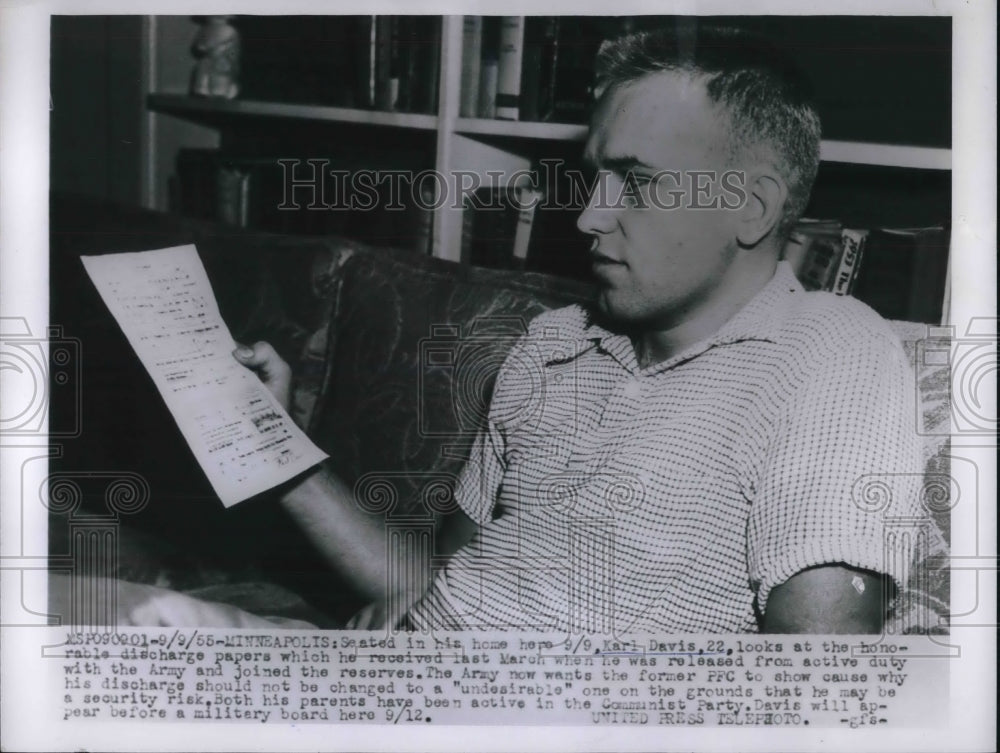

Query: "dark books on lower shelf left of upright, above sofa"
left=170, top=149, right=434, bottom=254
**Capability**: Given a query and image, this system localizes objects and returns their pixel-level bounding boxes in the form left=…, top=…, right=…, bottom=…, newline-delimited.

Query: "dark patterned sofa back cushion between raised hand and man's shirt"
left=310, top=244, right=593, bottom=516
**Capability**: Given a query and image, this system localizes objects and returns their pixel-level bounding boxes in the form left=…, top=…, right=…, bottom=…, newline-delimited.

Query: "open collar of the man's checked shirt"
left=545, top=261, right=804, bottom=375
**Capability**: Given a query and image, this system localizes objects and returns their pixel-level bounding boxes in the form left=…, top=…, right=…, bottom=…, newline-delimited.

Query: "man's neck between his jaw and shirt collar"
left=633, top=258, right=778, bottom=368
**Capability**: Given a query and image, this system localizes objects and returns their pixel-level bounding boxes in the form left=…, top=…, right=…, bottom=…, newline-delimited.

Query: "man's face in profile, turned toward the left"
left=577, top=72, right=737, bottom=329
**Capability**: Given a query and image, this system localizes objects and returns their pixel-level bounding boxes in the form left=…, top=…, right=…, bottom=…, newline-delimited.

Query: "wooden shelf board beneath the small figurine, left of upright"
left=147, top=94, right=438, bottom=131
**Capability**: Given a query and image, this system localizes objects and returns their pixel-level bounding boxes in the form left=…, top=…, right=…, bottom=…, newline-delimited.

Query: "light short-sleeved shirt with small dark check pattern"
left=409, top=262, right=923, bottom=634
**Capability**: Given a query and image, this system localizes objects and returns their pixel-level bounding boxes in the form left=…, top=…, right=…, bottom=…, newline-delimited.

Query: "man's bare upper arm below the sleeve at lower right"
left=762, top=565, right=892, bottom=634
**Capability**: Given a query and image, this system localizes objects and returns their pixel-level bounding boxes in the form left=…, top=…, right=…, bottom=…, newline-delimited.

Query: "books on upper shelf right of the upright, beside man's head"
left=459, top=16, right=629, bottom=123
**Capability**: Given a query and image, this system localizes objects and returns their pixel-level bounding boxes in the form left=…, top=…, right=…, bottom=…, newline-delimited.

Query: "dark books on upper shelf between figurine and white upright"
left=233, top=15, right=441, bottom=114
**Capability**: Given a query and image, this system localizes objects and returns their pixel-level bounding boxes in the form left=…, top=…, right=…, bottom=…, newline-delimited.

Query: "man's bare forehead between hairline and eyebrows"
left=584, top=71, right=725, bottom=167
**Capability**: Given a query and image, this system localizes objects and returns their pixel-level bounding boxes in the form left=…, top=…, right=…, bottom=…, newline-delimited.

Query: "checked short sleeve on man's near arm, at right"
left=747, top=326, right=925, bottom=613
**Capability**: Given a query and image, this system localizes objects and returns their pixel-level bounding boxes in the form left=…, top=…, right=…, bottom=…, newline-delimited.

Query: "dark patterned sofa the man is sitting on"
left=50, top=196, right=950, bottom=630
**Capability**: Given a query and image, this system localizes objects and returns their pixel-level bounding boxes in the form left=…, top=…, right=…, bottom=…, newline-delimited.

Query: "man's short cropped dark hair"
left=596, top=25, right=820, bottom=236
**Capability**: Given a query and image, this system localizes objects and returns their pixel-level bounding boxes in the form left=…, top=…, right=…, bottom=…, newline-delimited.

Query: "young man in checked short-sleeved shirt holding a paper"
left=127, top=26, right=920, bottom=633
